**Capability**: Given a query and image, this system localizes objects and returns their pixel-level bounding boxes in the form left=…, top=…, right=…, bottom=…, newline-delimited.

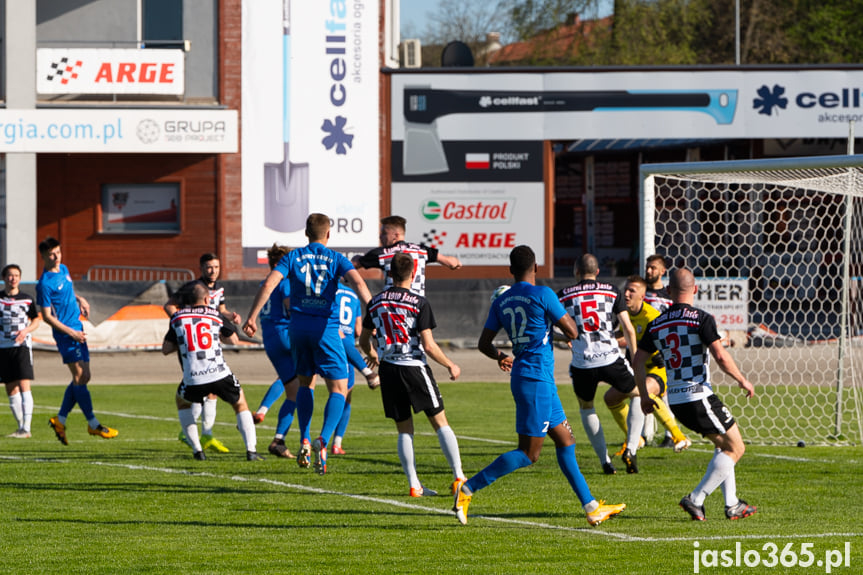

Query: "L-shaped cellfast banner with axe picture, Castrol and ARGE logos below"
left=391, top=70, right=863, bottom=265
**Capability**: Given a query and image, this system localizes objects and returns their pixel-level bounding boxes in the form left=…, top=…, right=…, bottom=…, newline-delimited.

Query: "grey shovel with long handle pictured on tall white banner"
left=264, top=0, right=309, bottom=232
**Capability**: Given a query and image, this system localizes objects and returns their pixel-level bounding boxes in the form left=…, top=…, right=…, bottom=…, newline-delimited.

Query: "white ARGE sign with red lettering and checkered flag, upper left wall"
left=36, top=48, right=185, bottom=96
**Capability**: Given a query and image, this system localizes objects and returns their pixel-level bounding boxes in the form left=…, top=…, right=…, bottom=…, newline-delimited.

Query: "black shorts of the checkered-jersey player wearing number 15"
left=378, top=361, right=443, bottom=421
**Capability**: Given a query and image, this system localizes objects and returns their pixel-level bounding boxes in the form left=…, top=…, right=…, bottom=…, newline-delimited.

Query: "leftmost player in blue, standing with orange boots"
left=36, top=237, right=118, bottom=445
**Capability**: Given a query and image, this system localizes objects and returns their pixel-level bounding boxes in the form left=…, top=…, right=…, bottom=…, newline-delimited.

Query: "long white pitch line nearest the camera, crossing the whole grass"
left=0, top=455, right=863, bottom=543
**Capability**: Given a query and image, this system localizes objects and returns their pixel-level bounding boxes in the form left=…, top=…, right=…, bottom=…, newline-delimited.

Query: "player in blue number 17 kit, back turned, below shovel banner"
left=243, top=213, right=371, bottom=475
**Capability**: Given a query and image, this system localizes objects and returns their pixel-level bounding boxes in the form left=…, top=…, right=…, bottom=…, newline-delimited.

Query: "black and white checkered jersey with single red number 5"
left=557, top=280, right=626, bottom=369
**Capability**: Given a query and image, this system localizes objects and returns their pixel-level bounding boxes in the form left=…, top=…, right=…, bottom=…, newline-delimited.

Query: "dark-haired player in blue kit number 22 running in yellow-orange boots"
left=453, top=246, right=626, bottom=525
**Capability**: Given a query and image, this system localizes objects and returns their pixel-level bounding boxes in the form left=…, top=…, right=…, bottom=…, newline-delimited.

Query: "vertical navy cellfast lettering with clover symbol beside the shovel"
left=321, top=0, right=354, bottom=156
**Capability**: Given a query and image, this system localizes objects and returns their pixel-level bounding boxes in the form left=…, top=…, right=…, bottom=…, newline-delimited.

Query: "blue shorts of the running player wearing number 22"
left=510, top=377, right=566, bottom=437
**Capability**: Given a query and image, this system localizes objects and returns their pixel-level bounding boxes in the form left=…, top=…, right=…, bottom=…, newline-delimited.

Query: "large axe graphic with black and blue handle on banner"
left=402, top=86, right=737, bottom=176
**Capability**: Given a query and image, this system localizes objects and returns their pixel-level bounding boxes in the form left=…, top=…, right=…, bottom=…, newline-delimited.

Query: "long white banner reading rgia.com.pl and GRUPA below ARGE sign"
left=0, top=108, right=239, bottom=154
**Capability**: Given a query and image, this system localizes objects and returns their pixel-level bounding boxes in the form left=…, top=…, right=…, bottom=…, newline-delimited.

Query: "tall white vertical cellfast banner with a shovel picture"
left=242, top=0, right=379, bottom=266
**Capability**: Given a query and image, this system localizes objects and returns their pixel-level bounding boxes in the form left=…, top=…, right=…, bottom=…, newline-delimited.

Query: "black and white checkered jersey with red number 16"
left=168, top=306, right=231, bottom=385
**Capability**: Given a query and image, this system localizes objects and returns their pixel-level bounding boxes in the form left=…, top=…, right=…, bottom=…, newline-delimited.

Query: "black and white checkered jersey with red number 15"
left=363, top=287, right=437, bottom=365
